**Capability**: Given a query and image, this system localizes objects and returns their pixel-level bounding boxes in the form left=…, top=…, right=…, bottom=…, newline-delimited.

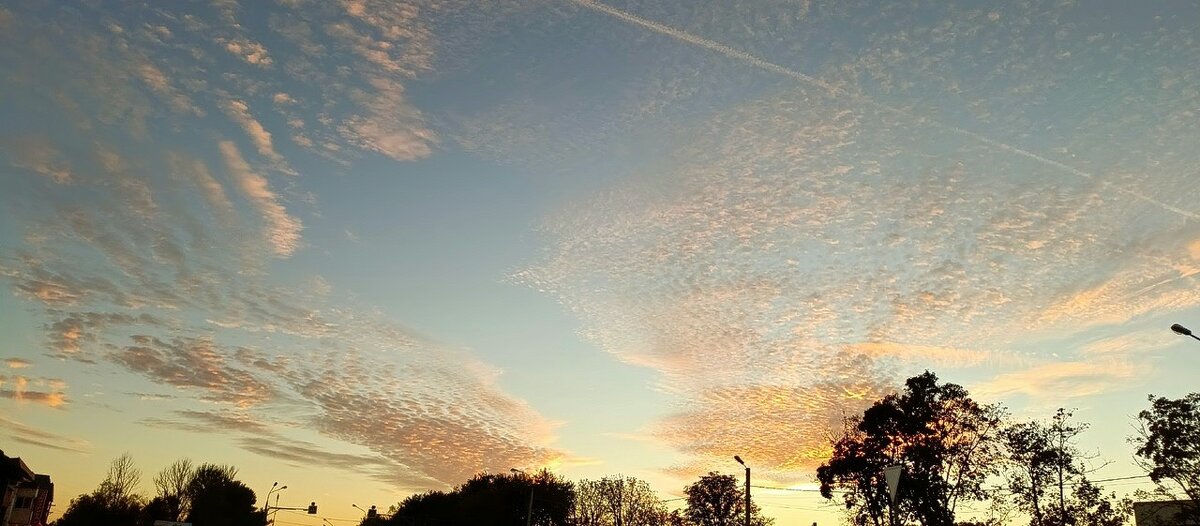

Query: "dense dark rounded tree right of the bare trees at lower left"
left=184, top=464, right=266, bottom=526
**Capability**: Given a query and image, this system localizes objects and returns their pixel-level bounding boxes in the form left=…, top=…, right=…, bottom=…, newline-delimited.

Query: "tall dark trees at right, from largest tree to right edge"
left=817, top=371, right=1200, bottom=526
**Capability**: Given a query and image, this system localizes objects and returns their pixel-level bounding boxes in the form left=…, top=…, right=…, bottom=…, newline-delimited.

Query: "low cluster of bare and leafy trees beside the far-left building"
left=54, top=454, right=266, bottom=526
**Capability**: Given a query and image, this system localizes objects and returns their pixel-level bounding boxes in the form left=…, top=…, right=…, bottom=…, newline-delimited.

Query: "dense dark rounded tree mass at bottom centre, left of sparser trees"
left=386, top=470, right=575, bottom=526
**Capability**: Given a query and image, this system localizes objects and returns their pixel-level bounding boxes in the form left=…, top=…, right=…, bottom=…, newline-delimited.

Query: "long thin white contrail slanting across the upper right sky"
left=566, top=0, right=1200, bottom=220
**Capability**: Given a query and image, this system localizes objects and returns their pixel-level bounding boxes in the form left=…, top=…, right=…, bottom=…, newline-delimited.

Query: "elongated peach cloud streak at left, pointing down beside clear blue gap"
left=218, top=141, right=304, bottom=257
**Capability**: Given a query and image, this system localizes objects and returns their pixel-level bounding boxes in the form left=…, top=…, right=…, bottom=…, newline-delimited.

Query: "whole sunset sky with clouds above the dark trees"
left=0, top=0, right=1200, bottom=525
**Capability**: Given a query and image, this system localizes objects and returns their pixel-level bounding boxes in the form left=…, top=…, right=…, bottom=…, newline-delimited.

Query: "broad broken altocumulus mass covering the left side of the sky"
left=0, top=2, right=565, bottom=488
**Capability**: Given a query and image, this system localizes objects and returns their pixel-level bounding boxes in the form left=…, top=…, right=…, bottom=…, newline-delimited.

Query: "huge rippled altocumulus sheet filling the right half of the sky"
left=511, top=2, right=1200, bottom=478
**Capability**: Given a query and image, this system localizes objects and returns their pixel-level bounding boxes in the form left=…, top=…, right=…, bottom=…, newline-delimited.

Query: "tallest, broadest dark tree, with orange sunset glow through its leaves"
left=817, top=371, right=1003, bottom=526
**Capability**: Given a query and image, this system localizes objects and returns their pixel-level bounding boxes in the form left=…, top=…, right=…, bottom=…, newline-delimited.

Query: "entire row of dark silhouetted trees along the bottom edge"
left=55, top=371, right=1200, bottom=526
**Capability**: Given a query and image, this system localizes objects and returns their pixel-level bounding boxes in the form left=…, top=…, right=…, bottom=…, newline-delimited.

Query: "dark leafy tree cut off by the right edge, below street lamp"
left=1130, top=393, right=1200, bottom=520
